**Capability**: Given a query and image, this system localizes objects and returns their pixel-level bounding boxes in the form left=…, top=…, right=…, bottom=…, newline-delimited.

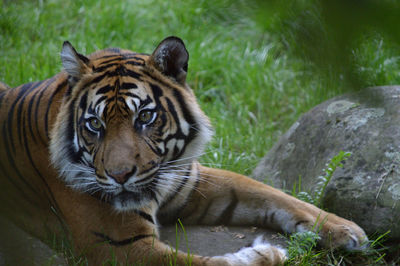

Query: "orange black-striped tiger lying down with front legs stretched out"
left=0, top=36, right=368, bottom=265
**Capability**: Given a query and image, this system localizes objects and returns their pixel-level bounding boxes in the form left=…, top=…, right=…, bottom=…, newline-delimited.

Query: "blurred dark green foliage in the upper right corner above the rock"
left=254, top=0, right=400, bottom=90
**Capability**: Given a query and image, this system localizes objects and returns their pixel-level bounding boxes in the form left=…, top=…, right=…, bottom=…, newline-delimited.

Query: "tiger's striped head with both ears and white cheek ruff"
left=50, top=37, right=212, bottom=211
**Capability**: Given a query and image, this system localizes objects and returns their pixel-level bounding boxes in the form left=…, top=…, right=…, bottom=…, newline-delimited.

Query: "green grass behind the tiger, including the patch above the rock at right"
left=0, top=0, right=400, bottom=262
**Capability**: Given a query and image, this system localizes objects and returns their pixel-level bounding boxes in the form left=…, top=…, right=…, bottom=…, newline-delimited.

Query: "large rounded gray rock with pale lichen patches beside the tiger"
left=253, top=86, right=400, bottom=239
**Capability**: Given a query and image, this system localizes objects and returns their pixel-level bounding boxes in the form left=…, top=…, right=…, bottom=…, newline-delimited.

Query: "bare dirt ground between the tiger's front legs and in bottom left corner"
left=0, top=218, right=285, bottom=266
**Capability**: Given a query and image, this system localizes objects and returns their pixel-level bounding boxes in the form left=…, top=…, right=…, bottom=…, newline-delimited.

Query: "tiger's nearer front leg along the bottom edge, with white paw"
left=57, top=185, right=286, bottom=266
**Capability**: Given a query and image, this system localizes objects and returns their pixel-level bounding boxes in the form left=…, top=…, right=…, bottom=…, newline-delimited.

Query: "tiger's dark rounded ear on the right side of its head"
left=150, top=36, right=189, bottom=84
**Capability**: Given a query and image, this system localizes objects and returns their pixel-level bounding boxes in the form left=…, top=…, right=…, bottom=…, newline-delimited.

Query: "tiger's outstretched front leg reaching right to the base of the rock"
left=158, top=164, right=368, bottom=250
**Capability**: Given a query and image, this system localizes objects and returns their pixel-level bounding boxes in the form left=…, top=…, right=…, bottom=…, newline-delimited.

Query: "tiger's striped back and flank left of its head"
left=0, top=74, right=70, bottom=240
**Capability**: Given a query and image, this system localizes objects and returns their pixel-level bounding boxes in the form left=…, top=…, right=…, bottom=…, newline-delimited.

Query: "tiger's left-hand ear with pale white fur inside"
left=61, top=41, right=89, bottom=86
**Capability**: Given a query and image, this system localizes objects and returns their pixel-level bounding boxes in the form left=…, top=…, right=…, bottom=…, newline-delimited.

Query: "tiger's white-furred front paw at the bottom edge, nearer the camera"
left=222, top=236, right=287, bottom=266
